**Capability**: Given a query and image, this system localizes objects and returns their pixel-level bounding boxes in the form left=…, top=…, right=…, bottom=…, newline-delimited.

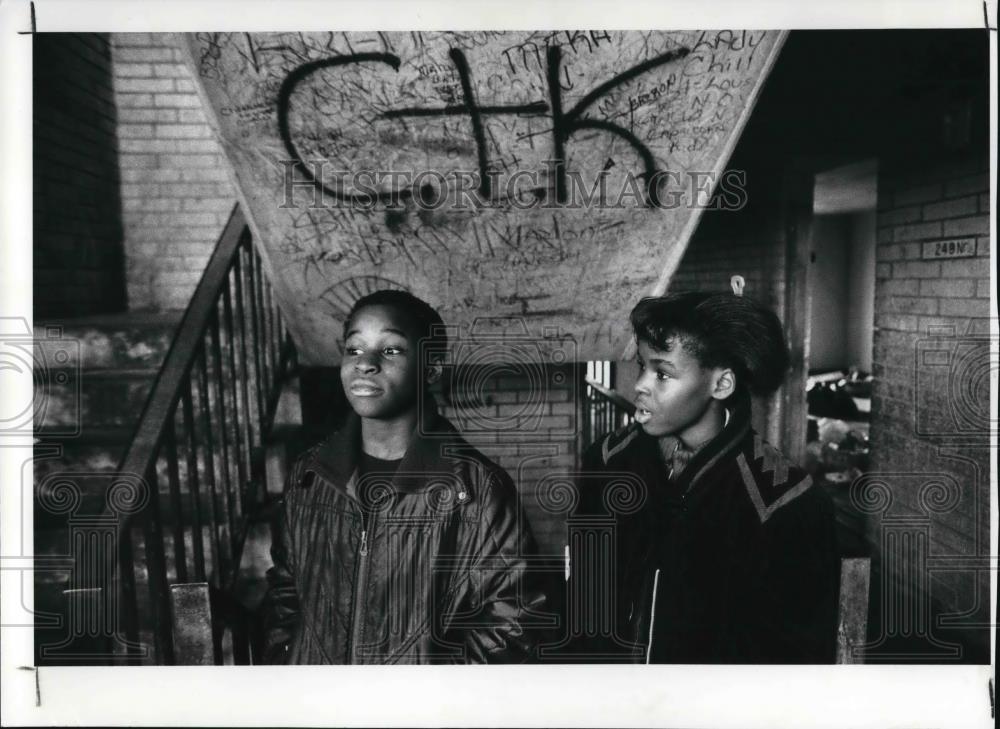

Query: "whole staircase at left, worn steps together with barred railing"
left=34, top=206, right=301, bottom=665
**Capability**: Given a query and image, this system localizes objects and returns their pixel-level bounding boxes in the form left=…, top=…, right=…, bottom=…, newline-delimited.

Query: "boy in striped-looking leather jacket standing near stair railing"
left=264, top=291, right=546, bottom=664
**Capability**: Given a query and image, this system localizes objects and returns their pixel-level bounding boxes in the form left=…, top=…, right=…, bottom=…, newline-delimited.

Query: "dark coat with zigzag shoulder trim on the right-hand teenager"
left=571, top=401, right=840, bottom=663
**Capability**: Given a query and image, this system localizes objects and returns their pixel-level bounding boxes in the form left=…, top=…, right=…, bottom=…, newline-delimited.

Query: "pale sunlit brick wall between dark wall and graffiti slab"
left=112, top=33, right=236, bottom=310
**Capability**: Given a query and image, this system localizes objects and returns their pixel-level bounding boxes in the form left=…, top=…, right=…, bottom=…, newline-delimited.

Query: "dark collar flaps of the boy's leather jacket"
left=312, top=395, right=467, bottom=492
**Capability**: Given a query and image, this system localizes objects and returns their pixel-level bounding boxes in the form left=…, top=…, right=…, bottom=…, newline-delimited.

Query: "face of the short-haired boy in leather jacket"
left=340, top=305, right=421, bottom=420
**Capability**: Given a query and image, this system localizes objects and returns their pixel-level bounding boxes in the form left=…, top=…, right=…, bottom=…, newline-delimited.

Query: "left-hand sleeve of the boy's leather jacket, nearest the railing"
left=262, top=461, right=303, bottom=664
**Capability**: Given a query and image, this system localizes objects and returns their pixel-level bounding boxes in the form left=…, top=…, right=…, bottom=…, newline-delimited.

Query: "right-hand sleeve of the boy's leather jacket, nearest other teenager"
left=462, top=469, right=551, bottom=663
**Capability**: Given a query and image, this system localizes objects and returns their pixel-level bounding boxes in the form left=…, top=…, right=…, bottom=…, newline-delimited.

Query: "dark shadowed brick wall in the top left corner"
left=33, top=33, right=125, bottom=317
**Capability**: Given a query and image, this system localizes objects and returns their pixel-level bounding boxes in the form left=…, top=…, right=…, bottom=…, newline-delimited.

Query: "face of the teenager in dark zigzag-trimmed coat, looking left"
left=635, top=338, right=717, bottom=440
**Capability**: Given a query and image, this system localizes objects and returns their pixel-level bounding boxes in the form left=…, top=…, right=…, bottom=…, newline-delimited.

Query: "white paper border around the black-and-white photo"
left=0, top=0, right=997, bottom=729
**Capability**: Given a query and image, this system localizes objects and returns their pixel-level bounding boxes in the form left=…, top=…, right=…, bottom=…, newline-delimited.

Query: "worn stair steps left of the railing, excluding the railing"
left=34, top=312, right=182, bottom=665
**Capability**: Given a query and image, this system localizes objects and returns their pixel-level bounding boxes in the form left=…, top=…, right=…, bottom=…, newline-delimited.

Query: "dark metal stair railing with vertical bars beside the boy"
left=105, top=205, right=295, bottom=664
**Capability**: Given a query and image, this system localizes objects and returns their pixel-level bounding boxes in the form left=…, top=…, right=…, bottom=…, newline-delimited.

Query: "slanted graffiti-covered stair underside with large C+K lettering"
left=181, top=30, right=783, bottom=365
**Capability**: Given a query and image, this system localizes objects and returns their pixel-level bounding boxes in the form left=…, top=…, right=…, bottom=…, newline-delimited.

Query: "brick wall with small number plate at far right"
left=870, top=154, right=996, bottom=658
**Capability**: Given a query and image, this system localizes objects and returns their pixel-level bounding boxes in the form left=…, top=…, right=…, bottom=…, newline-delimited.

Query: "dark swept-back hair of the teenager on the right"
left=629, top=292, right=789, bottom=395
